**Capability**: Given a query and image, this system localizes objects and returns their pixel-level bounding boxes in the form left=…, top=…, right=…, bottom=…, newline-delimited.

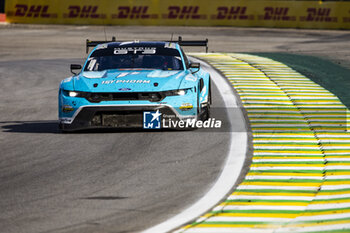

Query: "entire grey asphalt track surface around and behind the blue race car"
left=0, top=25, right=350, bottom=232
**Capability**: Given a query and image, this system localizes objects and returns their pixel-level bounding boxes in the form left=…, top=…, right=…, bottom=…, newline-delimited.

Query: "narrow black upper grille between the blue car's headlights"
left=85, top=92, right=165, bottom=103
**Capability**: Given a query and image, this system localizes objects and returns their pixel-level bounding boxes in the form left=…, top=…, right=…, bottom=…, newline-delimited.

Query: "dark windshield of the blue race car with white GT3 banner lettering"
left=84, top=47, right=183, bottom=71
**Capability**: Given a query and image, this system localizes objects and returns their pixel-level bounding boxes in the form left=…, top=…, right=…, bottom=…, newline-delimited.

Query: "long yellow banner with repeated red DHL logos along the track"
left=5, top=0, right=350, bottom=29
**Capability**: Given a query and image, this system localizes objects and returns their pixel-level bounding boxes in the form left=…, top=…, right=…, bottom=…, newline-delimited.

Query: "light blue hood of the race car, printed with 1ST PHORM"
left=73, top=70, right=196, bottom=92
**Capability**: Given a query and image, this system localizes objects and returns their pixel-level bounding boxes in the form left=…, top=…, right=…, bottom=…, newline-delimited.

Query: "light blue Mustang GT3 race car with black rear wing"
left=58, top=38, right=212, bottom=131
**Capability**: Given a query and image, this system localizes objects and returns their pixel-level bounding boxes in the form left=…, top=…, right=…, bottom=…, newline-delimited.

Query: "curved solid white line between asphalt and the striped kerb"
left=143, top=59, right=248, bottom=233
